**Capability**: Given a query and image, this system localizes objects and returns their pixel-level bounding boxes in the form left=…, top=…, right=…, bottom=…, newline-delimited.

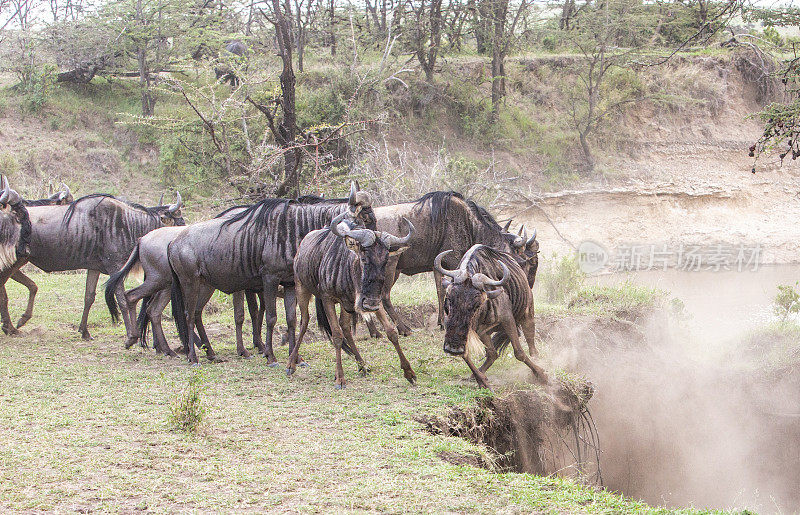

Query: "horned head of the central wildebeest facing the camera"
left=330, top=212, right=414, bottom=312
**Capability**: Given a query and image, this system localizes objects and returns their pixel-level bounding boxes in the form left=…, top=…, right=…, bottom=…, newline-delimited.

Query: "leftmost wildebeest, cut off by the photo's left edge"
left=0, top=176, right=31, bottom=334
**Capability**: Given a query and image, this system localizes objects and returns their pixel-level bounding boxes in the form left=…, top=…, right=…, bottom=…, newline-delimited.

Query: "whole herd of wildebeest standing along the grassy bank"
left=0, top=177, right=548, bottom=388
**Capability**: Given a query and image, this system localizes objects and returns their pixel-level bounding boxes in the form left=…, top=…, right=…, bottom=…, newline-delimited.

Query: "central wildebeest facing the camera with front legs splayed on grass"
left=286, top=213, right=416, bottom=388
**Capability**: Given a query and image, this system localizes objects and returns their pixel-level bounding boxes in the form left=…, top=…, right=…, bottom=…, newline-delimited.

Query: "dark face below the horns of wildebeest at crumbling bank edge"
left=444, top=281, right=486, bottom=356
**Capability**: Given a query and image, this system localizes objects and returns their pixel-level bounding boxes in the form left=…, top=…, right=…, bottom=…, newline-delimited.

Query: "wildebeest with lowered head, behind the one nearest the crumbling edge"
left=375, top=191, right=538, bottom=336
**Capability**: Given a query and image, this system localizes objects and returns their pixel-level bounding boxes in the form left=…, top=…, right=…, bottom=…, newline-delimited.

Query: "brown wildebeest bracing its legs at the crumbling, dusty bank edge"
left=434, top=245, right=548, bottom=388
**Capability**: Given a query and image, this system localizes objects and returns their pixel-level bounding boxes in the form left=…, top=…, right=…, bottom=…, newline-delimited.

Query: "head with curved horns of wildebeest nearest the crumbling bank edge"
left=433, top=250, right=509, bottom=356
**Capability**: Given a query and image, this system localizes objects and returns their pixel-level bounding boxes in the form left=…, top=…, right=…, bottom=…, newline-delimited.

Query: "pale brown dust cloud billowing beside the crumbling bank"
left=539, top=268, right=800, bottom=513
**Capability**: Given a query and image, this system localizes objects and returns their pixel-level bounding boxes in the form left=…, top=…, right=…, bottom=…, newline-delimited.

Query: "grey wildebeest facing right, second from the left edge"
left=28, top=193, right=185, bottom=339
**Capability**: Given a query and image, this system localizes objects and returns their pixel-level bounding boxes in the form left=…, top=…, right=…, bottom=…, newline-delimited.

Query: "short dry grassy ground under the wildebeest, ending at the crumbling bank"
left=0, top=274, right=692, bottom=513
